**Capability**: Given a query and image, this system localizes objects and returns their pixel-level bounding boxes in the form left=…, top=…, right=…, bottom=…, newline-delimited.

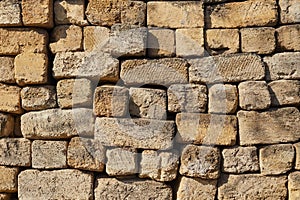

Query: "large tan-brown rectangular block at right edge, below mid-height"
left=238, top=108, right=300, bottom=145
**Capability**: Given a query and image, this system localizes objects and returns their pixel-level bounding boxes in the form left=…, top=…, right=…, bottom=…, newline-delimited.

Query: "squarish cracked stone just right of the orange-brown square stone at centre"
left=129, top=88, right=167, bottom=119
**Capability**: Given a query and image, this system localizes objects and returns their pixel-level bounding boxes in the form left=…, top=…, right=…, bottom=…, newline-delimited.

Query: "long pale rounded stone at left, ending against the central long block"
left=21, top=108, right=94, bottom=139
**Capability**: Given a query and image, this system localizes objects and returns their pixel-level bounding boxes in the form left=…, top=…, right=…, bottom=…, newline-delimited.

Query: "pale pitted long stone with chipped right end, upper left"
left=52, top=52, right=119, bottom=81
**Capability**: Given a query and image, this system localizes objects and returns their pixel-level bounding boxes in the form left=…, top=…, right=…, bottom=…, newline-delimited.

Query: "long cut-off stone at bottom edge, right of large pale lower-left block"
left=94, top=177, right=172, bottom=200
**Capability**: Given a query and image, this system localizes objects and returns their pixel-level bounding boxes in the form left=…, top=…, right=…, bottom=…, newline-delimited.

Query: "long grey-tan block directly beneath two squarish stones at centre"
left=95, top=118, right=175, bottom=149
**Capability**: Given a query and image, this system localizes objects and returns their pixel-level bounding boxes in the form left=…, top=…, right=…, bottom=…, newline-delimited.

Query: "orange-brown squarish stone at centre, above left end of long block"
left=93, top=85, right=129, bottom=117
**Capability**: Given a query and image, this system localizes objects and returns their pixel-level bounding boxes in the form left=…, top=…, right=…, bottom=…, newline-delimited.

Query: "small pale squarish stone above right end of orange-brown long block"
left=208, top=84, right=239, bottom=114
